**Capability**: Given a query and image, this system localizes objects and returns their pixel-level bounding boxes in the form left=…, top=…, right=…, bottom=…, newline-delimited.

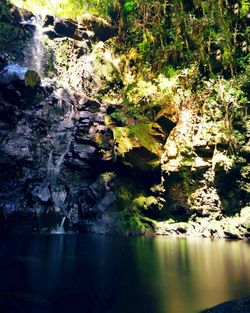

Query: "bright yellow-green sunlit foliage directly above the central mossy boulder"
left=122, top=64, right=199, bottom=121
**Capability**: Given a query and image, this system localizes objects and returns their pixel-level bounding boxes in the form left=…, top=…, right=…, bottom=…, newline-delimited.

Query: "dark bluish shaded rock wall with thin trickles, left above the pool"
left=0, top=70, right=114, bottom=231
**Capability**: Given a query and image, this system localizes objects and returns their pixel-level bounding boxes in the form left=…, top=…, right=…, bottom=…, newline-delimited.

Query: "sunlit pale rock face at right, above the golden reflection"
left=159, top=91, right=249, bottom=239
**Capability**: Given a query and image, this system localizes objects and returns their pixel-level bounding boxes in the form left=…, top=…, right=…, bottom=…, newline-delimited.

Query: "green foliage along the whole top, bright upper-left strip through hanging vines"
left=12, top=0, right=249, bottom=76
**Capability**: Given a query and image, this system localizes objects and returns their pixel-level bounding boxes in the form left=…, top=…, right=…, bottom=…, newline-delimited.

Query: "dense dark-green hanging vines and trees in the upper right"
left=118, top=0, right=249, bottom=76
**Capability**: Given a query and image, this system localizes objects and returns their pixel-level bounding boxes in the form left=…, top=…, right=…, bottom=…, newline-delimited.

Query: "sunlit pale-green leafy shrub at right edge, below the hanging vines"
left=203, top=77, right=248, bottom=154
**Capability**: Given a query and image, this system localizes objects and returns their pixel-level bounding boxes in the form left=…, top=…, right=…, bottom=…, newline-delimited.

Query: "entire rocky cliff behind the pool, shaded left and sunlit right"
left=0, top=2, right=250, bottom=235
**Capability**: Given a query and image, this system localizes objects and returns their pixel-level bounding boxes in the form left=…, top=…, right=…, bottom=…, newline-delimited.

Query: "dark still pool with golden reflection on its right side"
left=0, top=235, right=250, bottom=313
